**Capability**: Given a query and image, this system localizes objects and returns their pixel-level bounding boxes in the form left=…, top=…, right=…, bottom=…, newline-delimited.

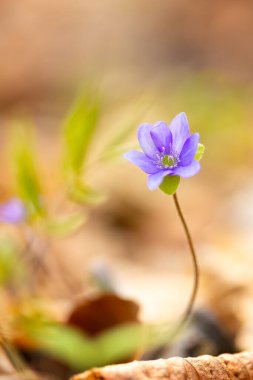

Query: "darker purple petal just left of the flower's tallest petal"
left=150, top=121, right=172, bottom=154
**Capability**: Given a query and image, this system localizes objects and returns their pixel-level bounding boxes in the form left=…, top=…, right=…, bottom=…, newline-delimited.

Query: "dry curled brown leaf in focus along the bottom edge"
left=72, top=352, right=253, bottom=380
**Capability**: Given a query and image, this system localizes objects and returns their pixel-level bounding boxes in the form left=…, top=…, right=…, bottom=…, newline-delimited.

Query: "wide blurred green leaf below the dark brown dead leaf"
left=17, top=317, right=149, bottom=370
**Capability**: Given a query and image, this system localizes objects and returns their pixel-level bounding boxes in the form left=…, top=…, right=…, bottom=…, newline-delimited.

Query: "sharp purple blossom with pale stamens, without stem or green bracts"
left=124, top=113, right=200, bottom=190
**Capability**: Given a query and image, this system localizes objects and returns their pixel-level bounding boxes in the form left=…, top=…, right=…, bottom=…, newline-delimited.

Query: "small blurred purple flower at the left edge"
left=0, top=198, right=26, bottom=224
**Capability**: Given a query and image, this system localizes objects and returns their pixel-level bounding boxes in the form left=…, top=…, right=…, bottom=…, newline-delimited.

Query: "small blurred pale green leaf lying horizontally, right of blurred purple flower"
left=45, top=213, right=86, bottom=237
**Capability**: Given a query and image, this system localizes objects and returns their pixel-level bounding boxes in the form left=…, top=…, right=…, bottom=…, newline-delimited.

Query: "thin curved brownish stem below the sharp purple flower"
left=173, top=193, right=199, bottom=329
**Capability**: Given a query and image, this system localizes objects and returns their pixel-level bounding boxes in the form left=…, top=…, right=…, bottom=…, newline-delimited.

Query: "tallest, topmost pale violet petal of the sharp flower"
left=169, top=112, right=190, bottom=153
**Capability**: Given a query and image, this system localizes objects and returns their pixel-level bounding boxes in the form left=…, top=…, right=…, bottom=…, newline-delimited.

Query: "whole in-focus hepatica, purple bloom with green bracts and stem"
left=124, top=112, right=204, bottom=332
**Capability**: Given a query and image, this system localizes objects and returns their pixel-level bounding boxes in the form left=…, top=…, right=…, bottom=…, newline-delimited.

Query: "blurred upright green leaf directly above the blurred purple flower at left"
left=12, top=126, right=44, bottom=218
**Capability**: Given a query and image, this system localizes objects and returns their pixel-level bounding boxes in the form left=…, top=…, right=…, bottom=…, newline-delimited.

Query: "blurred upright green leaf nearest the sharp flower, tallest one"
left=64, top=97, right=100, bottom=176
